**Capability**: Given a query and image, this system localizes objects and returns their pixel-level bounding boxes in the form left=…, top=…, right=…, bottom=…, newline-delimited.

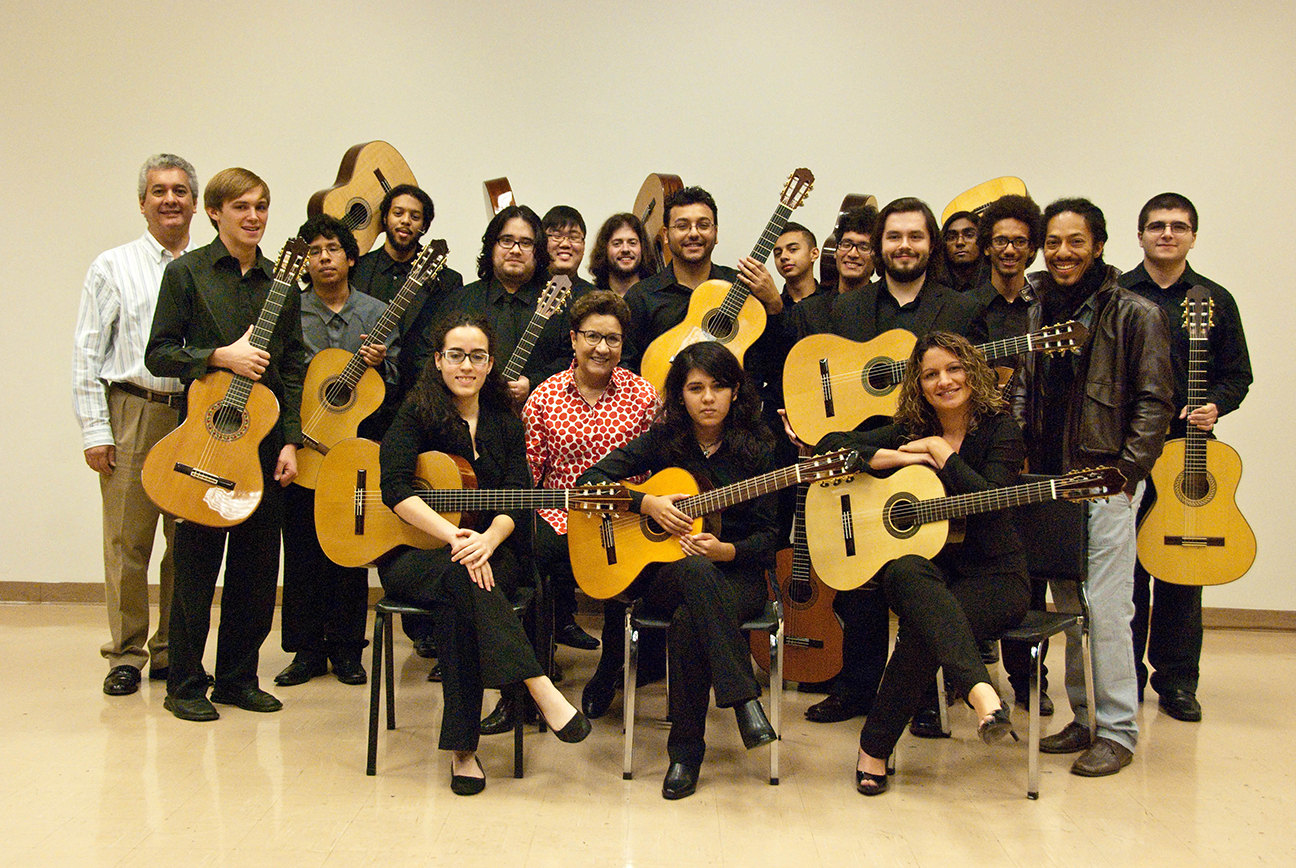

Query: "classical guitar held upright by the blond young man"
left=141, top=238, right=306, bottom=527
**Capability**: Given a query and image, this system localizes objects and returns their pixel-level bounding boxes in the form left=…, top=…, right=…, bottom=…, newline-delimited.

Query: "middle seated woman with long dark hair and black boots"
left=581, top=341, right=778, bottom=799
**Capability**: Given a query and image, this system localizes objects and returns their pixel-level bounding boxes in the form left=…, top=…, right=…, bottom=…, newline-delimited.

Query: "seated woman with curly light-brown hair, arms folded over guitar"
left=815, top=332, right=1030, bottom=795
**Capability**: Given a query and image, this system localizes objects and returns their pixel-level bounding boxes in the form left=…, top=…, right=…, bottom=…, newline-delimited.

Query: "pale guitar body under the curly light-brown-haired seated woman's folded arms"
left=806, top=465, right=950, bottom=591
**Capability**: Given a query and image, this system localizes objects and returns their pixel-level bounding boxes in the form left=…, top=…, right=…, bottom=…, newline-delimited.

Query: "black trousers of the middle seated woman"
left=629, top=554, right=767, bottom=763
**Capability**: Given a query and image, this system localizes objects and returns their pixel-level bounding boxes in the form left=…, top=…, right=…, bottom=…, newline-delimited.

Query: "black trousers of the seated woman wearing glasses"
left=378, top=545, right=544, bottom=751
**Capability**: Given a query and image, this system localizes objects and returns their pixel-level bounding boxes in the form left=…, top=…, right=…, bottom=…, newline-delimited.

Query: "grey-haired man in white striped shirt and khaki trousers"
left=73, top=154, right=198, bottom=696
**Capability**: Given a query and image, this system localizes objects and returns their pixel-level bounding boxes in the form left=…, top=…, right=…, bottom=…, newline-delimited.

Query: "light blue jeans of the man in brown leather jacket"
left=1050, top=482, right=1144, bottom=750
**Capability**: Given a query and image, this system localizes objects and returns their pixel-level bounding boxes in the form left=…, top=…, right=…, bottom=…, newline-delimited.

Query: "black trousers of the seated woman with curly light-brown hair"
left=859, top=554, right=1030, bottom=758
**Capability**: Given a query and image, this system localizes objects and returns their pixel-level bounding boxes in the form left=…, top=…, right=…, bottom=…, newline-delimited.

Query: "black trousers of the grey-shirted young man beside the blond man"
left=280, top=485, right=369, bottom=654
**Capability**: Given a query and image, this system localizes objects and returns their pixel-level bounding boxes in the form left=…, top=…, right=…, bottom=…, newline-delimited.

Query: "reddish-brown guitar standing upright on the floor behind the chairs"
left=750, top=486, right=842, bottom=683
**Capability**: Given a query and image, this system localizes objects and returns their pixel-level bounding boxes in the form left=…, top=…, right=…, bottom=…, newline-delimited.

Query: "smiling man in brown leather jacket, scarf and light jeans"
left=1015, top=200, right=1175, bottom=777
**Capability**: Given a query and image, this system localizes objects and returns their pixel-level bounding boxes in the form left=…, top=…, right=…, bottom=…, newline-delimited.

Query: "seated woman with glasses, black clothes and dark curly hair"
left=378, top=312, right=590, bottom=795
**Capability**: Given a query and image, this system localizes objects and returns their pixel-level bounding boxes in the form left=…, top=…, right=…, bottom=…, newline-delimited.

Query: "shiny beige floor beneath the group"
left=0, top=605, right=1296, bottom=868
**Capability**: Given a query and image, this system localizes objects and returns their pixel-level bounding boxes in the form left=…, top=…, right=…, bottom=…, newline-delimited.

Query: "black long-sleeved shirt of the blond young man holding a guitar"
left=144, top=237, right=306, bottom=455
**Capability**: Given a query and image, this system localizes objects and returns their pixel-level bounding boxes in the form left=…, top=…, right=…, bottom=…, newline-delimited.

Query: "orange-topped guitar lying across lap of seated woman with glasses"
left=315, top=438, right=630, bottom=566
